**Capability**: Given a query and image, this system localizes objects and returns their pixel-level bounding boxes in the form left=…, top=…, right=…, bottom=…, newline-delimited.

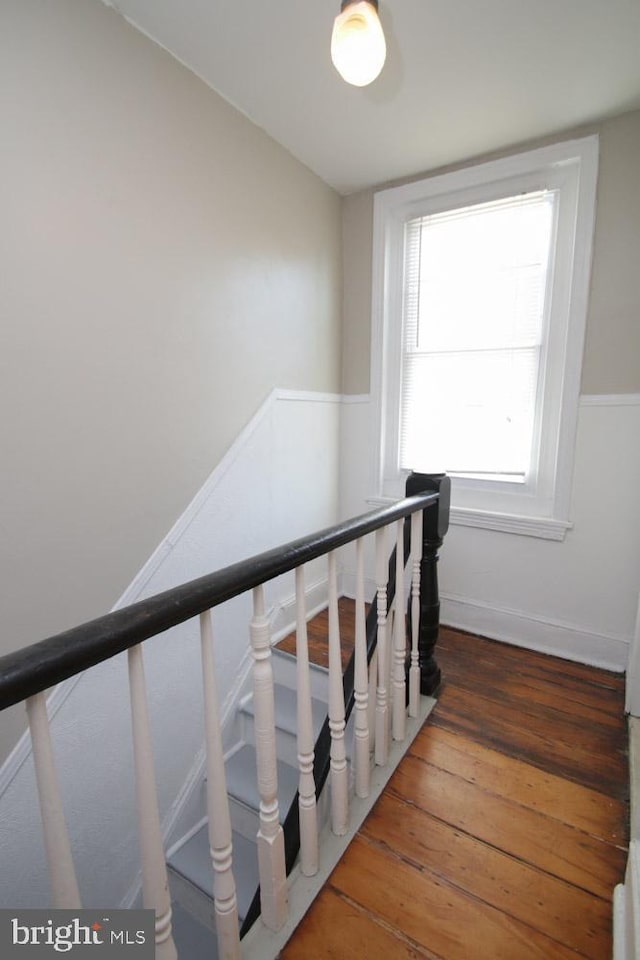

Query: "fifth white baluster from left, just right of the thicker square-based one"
left=295, top=567, right=318, bottom=877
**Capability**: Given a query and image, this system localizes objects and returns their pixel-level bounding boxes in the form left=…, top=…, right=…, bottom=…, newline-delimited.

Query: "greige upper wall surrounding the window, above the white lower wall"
left=342, top=111, right=640, bottom=394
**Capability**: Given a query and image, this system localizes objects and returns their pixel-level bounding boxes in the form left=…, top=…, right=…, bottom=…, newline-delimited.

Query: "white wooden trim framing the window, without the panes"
left=371, top=136, right=598, bottom=540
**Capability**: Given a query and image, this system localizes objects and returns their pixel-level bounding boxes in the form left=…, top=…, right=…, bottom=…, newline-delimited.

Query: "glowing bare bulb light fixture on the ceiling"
left=331, top=0, right=387, bottom=87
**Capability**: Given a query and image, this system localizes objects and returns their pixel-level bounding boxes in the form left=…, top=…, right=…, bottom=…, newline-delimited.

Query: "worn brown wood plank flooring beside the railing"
left=281, top=601, right=628, bottom=960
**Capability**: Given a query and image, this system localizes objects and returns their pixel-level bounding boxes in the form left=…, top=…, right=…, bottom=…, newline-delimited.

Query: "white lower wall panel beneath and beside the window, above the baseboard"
left=341, top=394, right=640, bottom=671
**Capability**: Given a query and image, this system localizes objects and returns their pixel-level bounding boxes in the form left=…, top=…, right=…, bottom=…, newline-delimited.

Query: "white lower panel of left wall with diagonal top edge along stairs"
left=0, top=390, right=341, bottom=907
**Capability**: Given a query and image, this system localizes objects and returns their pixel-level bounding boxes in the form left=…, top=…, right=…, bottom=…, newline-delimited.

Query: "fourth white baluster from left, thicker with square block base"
left=250, top=586, right=287, bottom=930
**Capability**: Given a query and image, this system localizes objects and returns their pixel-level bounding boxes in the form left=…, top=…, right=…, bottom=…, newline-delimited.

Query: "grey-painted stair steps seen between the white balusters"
left=167, top=648, right=328, bottom=960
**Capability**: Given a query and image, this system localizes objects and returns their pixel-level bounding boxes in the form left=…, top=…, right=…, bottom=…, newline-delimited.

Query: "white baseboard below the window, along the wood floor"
left=440, top=594, right=629, bottom=672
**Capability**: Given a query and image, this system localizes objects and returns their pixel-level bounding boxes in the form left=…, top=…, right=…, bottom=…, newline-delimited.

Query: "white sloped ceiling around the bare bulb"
left=105, top=0, right=640, bottom=193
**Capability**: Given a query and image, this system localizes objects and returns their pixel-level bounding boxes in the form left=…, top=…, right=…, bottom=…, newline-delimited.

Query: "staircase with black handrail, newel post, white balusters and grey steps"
left=0, top=474, right=450, bottom=960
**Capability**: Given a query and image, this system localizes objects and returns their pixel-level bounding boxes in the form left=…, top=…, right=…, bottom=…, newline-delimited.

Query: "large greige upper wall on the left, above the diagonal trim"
left=0, top=0, right=341, bottom=754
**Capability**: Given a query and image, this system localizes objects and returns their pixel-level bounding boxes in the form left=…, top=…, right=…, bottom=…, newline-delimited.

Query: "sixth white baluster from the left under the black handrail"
left=328, top=551, right=349, bottom=837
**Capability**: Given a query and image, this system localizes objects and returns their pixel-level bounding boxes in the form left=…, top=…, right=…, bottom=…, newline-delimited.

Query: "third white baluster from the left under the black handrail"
left=200, top=610, right=240, bottom=960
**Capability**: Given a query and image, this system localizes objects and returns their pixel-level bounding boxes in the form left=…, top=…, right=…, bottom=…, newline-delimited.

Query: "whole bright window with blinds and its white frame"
left=372, top=137, right=597, bottom=539
